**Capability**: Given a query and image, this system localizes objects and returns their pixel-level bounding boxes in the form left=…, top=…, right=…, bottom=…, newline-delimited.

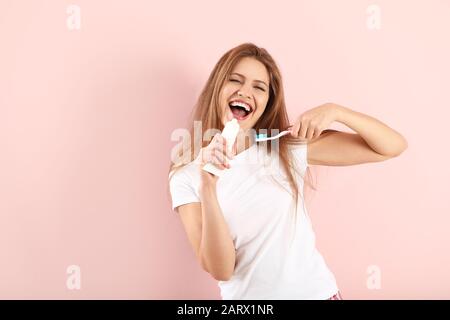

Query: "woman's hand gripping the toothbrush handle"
left=289, top=103, right=339, bottom=140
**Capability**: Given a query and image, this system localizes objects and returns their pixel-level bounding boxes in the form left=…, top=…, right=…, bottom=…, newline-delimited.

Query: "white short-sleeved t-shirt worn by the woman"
left=170, top=144, right=338, bottom=300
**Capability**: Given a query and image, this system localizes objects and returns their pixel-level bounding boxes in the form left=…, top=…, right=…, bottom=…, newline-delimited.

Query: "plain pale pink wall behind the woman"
left=0, top=0, right=450, bottom=299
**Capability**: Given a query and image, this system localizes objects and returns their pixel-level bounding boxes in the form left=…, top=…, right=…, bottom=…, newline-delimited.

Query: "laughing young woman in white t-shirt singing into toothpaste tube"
left=169, top=43, right=407, bottom=299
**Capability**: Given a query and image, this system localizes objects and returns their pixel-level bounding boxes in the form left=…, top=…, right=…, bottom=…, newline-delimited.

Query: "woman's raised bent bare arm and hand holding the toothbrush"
left=291, top=103, right=408, bottom=166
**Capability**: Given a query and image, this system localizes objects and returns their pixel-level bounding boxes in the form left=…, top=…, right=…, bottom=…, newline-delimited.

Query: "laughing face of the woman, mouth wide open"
left=220, top=57, right=270, bottom=130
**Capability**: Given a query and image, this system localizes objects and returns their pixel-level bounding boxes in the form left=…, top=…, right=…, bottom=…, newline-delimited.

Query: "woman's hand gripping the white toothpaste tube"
left=199, top=133, right=236, bottom=188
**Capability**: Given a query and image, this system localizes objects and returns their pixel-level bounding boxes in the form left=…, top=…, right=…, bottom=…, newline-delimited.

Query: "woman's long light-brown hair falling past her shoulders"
left=169, top=43, right=315, bottom=222
